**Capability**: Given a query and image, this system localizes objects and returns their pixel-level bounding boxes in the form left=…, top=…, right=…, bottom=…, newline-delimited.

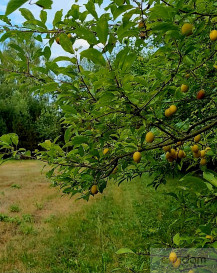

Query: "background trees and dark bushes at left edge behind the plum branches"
left=0, top=39, right=61, bottom=151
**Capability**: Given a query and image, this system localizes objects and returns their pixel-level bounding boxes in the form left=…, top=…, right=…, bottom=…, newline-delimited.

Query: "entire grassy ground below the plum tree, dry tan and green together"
left=0, top=161, right=180, bottom=273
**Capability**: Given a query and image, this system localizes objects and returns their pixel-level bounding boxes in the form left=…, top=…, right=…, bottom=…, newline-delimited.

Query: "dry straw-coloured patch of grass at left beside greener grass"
left=0, top=161, right=100, bottom=251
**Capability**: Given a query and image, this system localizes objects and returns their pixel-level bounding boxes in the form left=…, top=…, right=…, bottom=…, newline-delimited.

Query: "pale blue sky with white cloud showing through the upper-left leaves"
left=0, top=0, right=109, bottom=58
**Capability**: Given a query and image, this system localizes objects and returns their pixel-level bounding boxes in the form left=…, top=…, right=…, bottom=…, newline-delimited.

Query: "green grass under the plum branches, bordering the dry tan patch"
left=0, top=174, right=180, bottom=273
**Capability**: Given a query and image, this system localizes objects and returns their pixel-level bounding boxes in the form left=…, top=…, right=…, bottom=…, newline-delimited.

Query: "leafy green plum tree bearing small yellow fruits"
left=0, top=0, right=217, bottom=199
